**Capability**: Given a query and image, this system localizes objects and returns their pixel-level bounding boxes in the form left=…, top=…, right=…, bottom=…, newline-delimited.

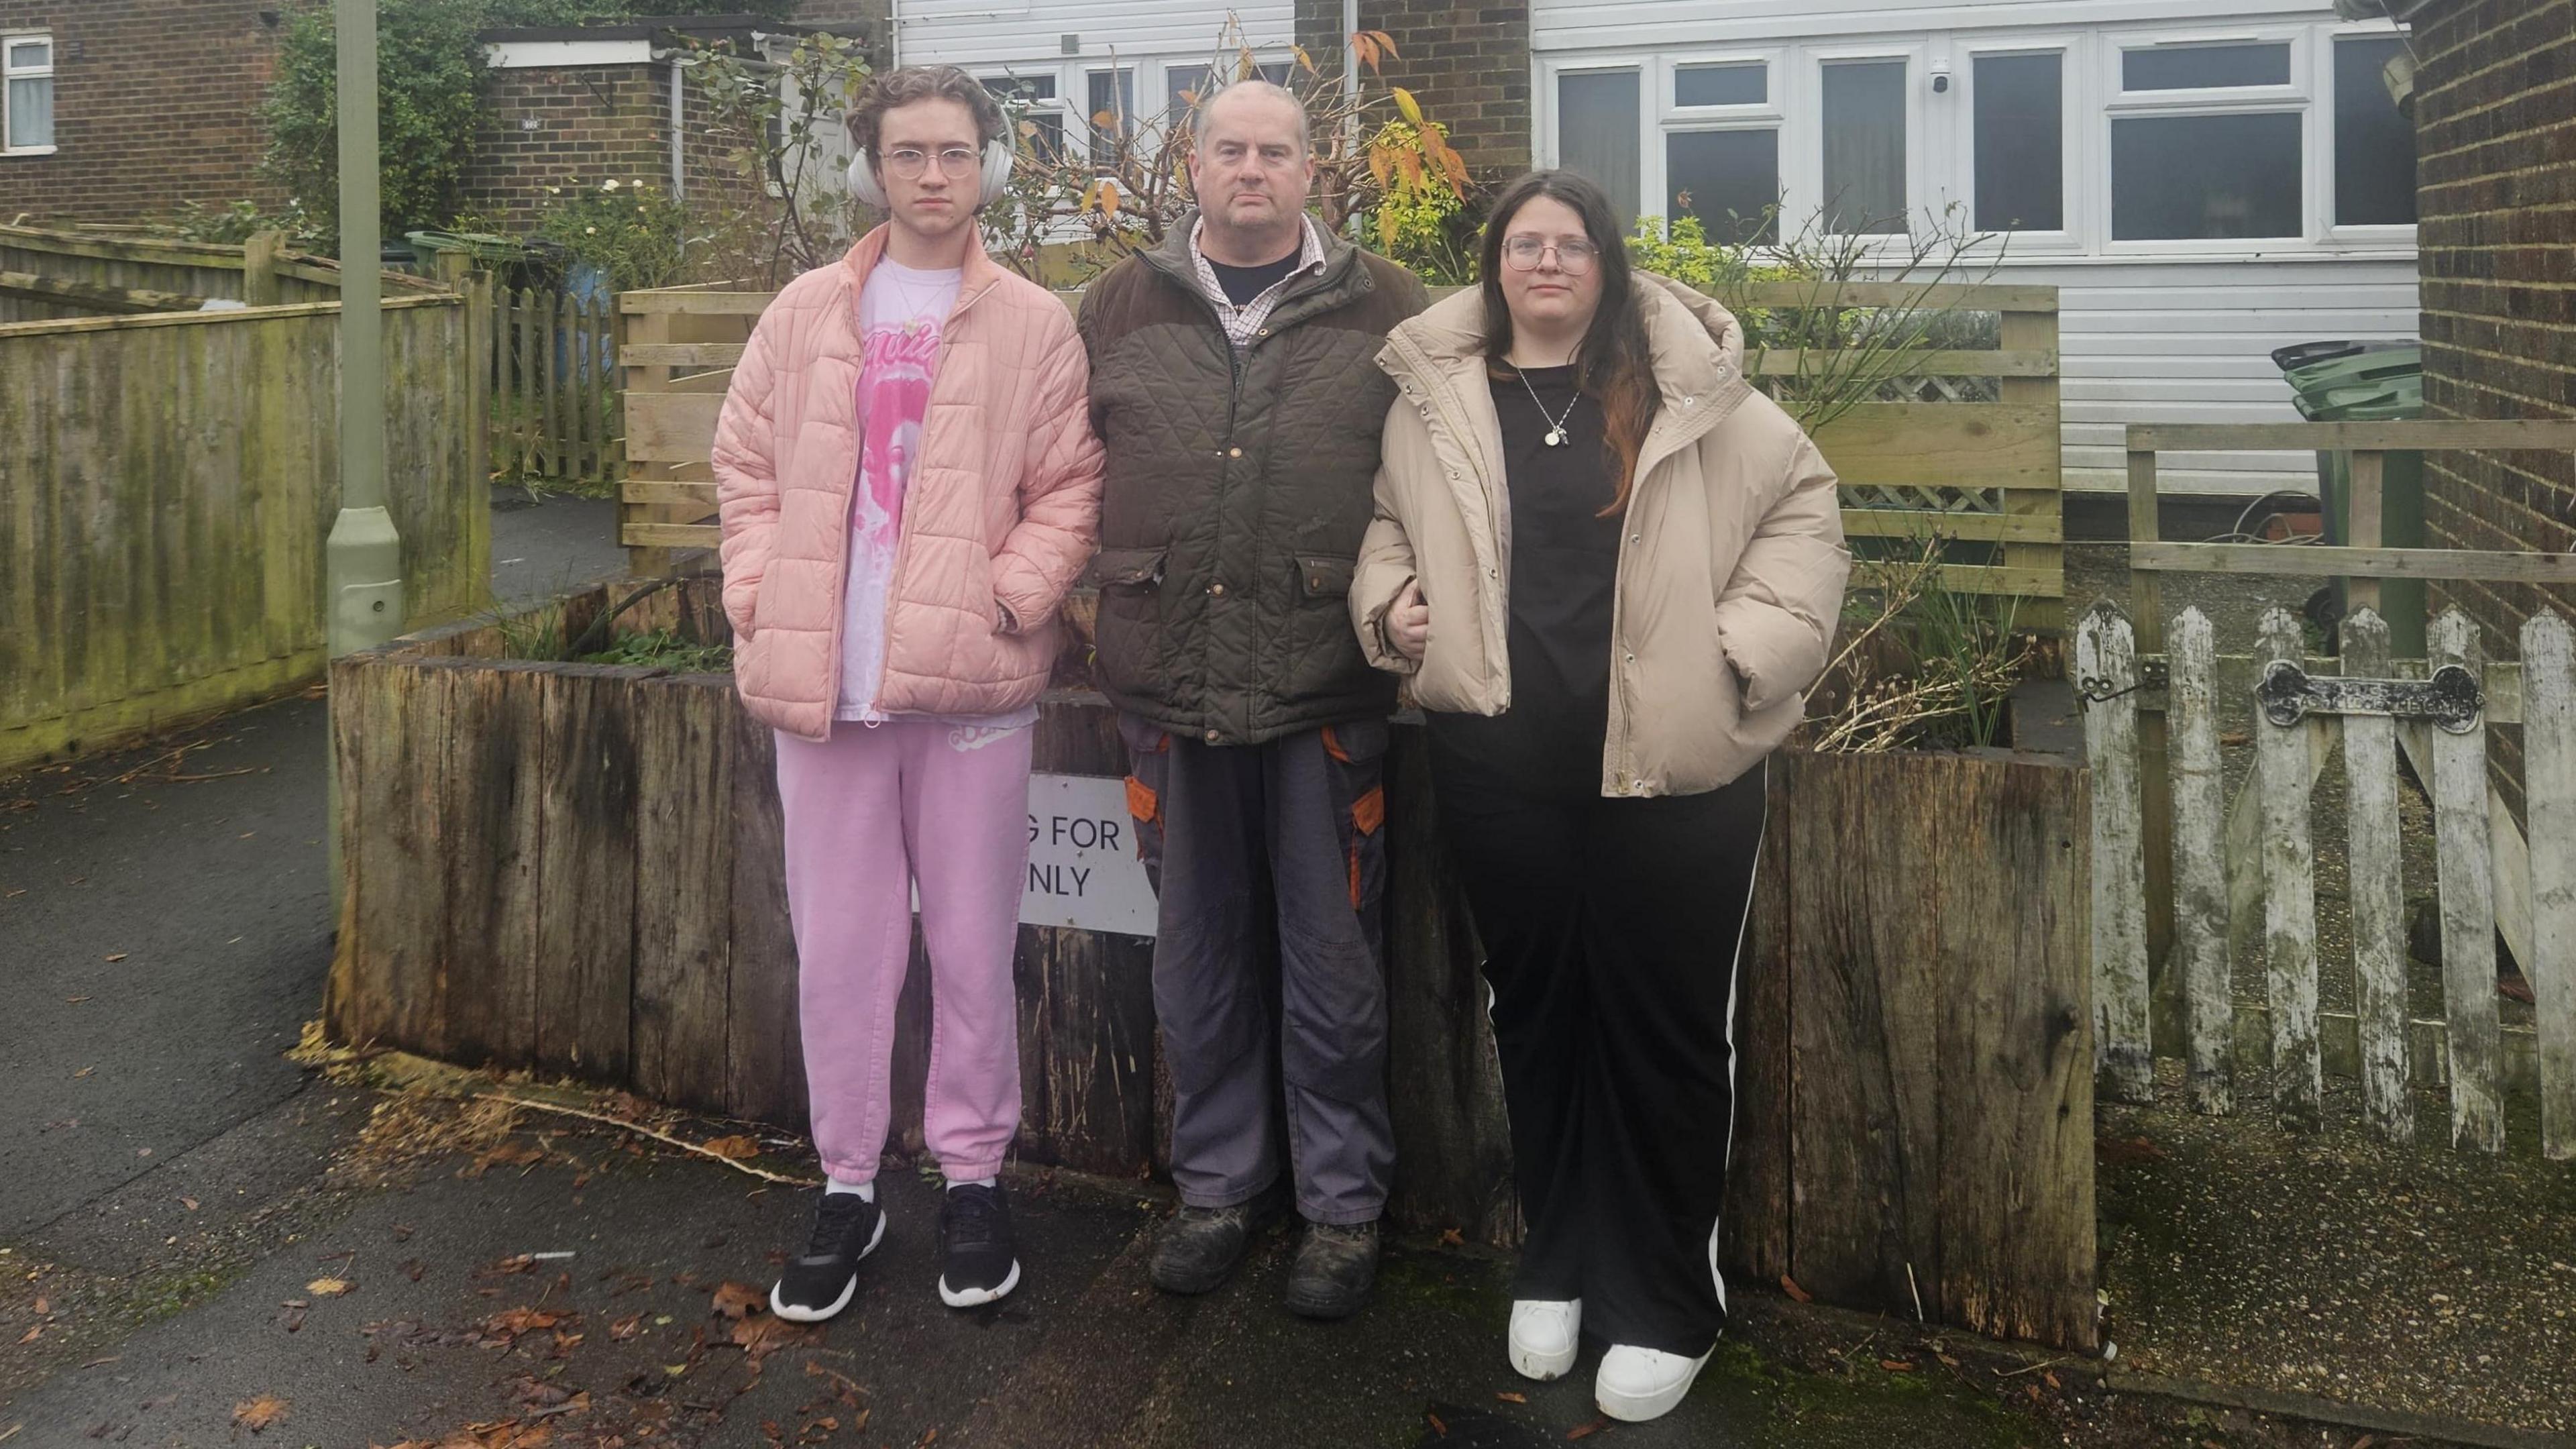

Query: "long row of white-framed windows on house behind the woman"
left=1533, top=18, right=2414, bottom=258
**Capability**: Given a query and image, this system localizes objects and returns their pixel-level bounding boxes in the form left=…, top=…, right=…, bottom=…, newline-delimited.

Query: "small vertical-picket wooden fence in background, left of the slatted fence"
left=474, top=278, right=623, bottom=482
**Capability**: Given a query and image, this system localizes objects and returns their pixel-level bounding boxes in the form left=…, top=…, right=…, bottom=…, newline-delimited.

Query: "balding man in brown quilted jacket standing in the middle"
left=1082, top=83, right=1425, bottom=1318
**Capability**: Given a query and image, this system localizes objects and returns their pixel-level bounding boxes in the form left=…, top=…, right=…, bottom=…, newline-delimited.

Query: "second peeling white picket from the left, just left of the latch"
left=2169, top=608, right=2236, bottom=1114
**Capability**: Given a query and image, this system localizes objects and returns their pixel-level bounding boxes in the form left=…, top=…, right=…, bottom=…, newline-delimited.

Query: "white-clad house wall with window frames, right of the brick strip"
left=1530, top=0, right=2416, bottom=495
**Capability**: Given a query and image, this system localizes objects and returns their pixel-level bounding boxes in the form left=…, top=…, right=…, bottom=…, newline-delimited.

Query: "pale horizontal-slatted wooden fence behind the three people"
left=619, top=281, right=2066, bottom=621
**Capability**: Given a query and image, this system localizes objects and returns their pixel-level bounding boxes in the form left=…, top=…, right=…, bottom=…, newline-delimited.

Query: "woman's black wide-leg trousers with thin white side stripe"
left=1432, top=743, right=1767, bottom=1358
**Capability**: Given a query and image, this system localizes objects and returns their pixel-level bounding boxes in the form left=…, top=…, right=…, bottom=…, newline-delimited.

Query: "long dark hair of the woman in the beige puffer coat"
left=1476, top=170, right=1664, bottom=519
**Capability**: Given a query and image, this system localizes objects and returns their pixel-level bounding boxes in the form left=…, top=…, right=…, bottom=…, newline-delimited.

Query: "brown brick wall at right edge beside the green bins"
left=2414, top=0, right=2576, bottom=807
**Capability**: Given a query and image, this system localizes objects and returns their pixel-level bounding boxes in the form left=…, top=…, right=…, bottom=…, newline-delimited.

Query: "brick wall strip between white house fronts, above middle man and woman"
left=1296, top=0, right=1530, bottom=180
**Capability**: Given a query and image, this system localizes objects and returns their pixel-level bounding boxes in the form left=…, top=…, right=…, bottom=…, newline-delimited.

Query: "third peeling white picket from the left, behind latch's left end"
left=2254, top=608, right=2326, bottom=1132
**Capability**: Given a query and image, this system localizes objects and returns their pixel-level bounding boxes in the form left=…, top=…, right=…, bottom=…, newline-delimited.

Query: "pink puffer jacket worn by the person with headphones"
left=714, top=227, right=1100, bottom=740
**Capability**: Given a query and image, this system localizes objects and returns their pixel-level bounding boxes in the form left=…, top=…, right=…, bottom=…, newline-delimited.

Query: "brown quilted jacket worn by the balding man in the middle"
left=1082, top=217, right=1425, bottom=745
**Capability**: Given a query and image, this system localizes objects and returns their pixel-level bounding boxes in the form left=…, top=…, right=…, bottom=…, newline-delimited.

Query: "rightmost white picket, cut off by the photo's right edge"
left=2522, top=614, right=2576, bottom=1163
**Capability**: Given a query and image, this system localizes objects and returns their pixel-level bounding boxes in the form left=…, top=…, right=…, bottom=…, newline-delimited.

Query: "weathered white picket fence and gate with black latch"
left=2076, top=592, right=2576, bottom=1161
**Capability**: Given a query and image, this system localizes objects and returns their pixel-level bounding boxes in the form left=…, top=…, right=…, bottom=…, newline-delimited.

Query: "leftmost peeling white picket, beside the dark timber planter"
left=2076, top=603, right=2156, bottom=1101
